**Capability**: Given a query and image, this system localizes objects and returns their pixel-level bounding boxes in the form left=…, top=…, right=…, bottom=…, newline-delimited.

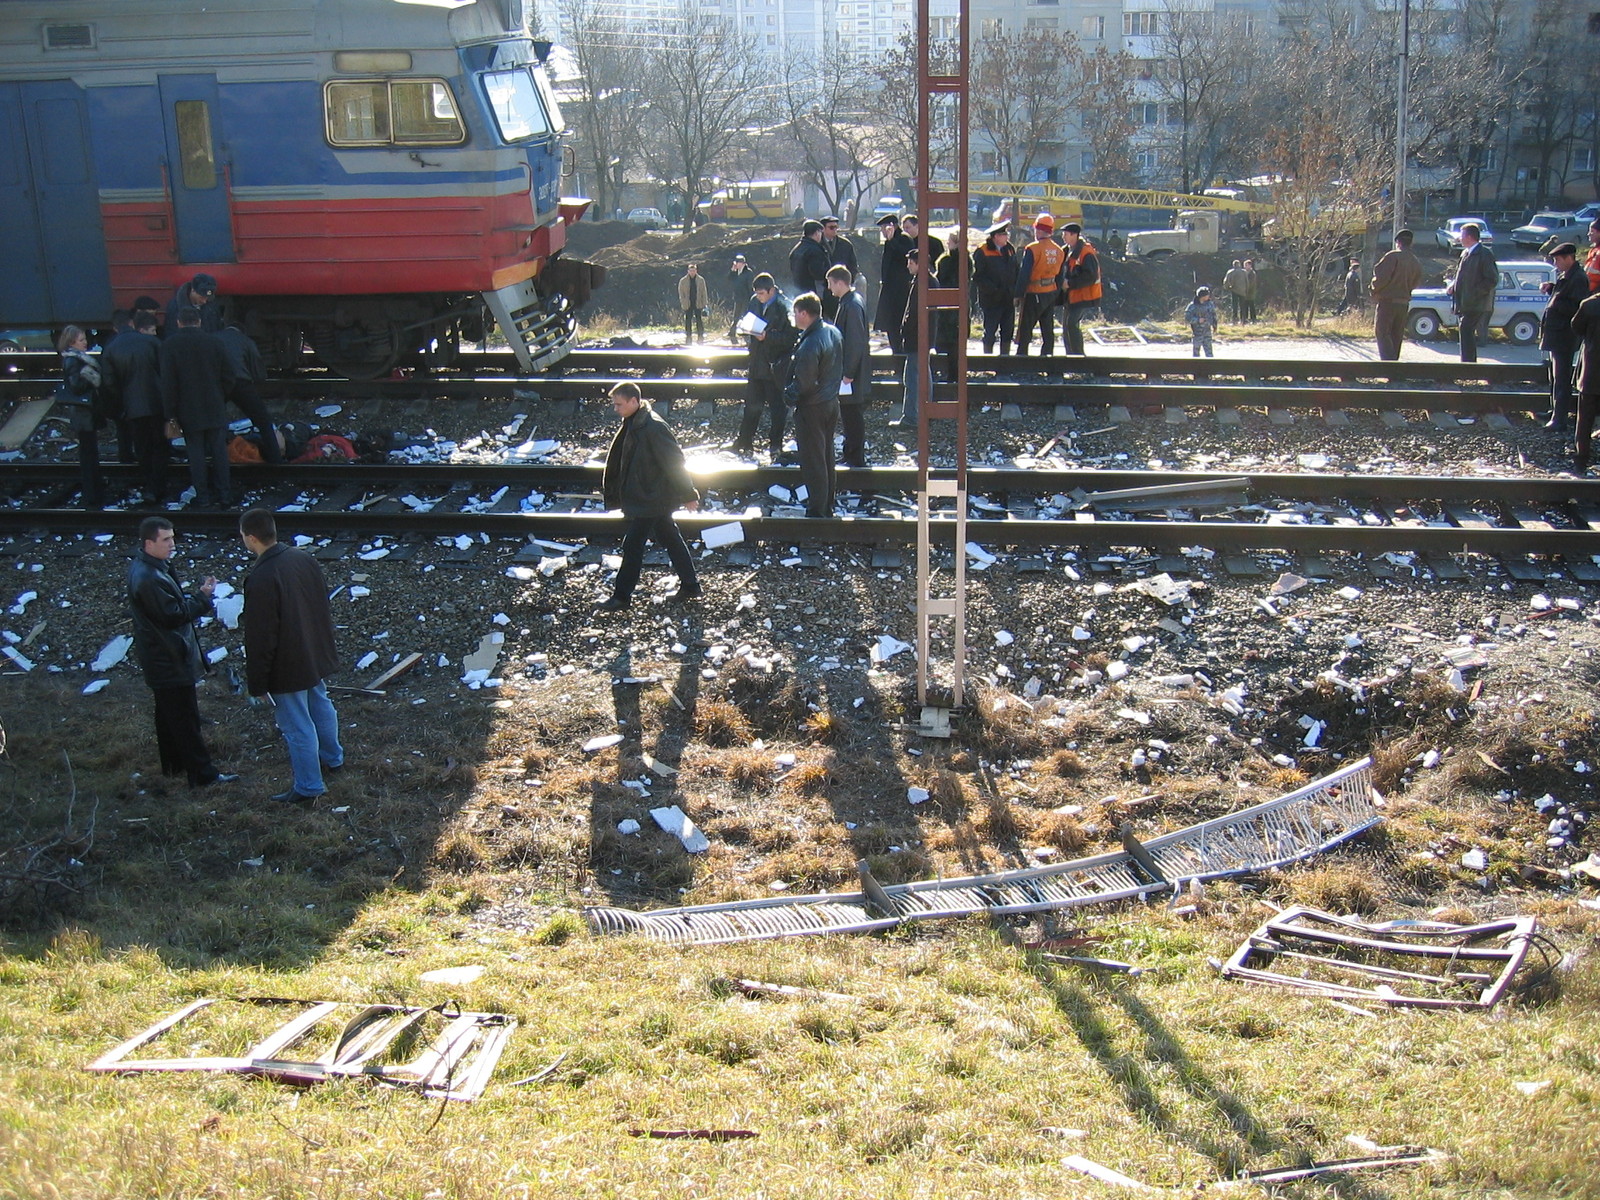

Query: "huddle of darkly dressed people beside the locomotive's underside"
left=56, top=274, right=283, bottom=509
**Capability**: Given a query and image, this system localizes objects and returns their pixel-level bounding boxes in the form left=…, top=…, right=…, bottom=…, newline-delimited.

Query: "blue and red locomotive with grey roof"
left=0, top=0, right=600, bottom=378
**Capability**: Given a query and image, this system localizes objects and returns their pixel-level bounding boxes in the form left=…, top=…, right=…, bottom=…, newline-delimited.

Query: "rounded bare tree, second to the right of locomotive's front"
left=642, top=0, right=773, bottom=222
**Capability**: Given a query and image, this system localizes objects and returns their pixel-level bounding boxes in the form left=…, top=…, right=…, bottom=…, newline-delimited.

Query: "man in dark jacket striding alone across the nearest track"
left=598, top=382, right=701, bottom=613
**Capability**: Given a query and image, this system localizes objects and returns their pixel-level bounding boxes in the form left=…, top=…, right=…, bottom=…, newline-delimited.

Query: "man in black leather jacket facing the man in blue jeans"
left=128, top=517, right=238, bottom=787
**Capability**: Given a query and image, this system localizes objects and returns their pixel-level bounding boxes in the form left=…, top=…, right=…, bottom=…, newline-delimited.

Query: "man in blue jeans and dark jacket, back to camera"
left=238, top=509, right=344, bottom=805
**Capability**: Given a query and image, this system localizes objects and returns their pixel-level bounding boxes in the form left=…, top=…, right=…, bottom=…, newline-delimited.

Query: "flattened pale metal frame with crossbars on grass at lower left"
left=86, top=997, right=517, bottom=1101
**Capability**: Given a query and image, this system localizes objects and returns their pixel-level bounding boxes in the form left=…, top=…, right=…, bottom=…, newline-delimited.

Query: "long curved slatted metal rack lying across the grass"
left=584, top=758, right=1382, bottom=946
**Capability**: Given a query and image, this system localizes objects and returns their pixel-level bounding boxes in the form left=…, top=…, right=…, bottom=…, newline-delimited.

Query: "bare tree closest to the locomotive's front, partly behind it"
left=563, top=0, right=650, bottom=216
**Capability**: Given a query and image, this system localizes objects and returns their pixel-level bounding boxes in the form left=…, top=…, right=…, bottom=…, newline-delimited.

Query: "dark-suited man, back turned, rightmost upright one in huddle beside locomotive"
left=160, top=304, right=234, bottom=509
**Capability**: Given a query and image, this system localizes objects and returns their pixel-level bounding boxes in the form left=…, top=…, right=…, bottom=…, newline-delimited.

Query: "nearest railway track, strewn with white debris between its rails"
left=0, top=464, right=1600, bottom=569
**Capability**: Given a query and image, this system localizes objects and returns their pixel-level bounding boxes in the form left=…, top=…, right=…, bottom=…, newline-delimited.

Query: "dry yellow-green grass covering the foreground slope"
left=0, top=659, right=1600, bottom=1200
